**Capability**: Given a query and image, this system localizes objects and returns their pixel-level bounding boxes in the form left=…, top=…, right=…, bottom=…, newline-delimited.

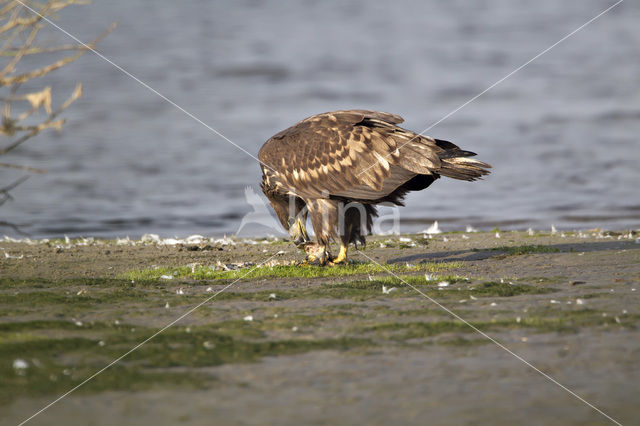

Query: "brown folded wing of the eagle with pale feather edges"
left=258, top=110, right=444, bottom=199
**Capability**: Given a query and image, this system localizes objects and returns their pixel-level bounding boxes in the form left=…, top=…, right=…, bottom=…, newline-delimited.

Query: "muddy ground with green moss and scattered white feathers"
left=0, top=230, right=640, bottom=425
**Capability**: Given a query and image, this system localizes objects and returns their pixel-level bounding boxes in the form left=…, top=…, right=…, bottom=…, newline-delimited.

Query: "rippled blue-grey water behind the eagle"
left=0, top=0, right=640, bottom=237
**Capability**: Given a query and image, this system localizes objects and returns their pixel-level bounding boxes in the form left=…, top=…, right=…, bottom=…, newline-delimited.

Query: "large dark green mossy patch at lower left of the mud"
left=0, top=322, right=371, bottom=404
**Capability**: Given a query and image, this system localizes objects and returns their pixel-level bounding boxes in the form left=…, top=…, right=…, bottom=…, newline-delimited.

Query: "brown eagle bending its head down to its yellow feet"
left=258, top=109, right=491, bottom=265
